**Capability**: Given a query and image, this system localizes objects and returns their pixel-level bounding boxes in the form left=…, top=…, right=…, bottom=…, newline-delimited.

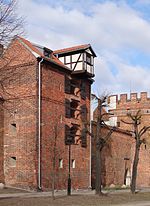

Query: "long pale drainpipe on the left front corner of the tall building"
left=38, top=59, right=43, bottom=190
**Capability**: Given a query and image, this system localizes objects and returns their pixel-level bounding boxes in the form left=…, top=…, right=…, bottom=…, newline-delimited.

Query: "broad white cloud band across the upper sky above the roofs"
left=20, top=0, right=150, bottom=51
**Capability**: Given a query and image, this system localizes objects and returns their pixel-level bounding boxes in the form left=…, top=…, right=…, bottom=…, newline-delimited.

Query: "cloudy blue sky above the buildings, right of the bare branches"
left=18, top=0, right=150, bottom=94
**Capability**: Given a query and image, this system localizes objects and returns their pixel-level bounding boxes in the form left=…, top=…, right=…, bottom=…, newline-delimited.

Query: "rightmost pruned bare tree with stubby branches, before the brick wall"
left=122, top=110, right=150, bottom=194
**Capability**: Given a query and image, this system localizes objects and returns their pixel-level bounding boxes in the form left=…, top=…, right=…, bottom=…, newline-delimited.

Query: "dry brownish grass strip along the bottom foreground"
left=0, top=192, right=150, bottom=206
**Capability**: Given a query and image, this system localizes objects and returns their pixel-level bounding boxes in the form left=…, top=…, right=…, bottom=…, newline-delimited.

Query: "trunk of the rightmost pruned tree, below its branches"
left=131, top=141, right=140, bottom=194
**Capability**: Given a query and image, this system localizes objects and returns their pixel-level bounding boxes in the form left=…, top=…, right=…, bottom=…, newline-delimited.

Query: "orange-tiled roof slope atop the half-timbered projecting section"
left=54, top=44, right=91, bottom=54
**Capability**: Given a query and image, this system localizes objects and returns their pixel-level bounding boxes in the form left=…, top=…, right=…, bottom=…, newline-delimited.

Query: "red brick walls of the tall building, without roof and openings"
left=0, top=37, right=91, bottom=190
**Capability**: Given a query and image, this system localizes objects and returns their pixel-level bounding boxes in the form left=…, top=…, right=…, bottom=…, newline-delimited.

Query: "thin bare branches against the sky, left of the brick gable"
left=0, top=0, right=24, bottom=46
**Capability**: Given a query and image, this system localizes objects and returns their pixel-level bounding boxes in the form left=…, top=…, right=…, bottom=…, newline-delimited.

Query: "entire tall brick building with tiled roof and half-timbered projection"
left=0, top=37, right=96, bottom=190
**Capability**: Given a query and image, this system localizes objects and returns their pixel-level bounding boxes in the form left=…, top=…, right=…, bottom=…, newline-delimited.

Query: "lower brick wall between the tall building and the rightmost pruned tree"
left=92, top=123, right=133, bottom=188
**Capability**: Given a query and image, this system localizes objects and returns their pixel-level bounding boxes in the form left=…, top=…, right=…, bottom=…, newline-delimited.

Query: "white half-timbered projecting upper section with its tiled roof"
left=54, top=44, right=96, bottom=77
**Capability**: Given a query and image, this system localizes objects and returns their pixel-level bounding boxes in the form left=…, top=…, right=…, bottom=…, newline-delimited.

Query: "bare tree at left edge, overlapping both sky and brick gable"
left=0, top=0, right=24, bottom=99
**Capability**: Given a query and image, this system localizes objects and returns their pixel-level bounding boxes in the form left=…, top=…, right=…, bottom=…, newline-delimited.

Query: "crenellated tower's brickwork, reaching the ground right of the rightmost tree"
left=108, top=92, right=150, bottom=187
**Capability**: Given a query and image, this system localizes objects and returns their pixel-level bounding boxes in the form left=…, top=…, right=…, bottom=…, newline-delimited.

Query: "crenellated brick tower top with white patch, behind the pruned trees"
left=108, top=92, right=150, bottom=128
